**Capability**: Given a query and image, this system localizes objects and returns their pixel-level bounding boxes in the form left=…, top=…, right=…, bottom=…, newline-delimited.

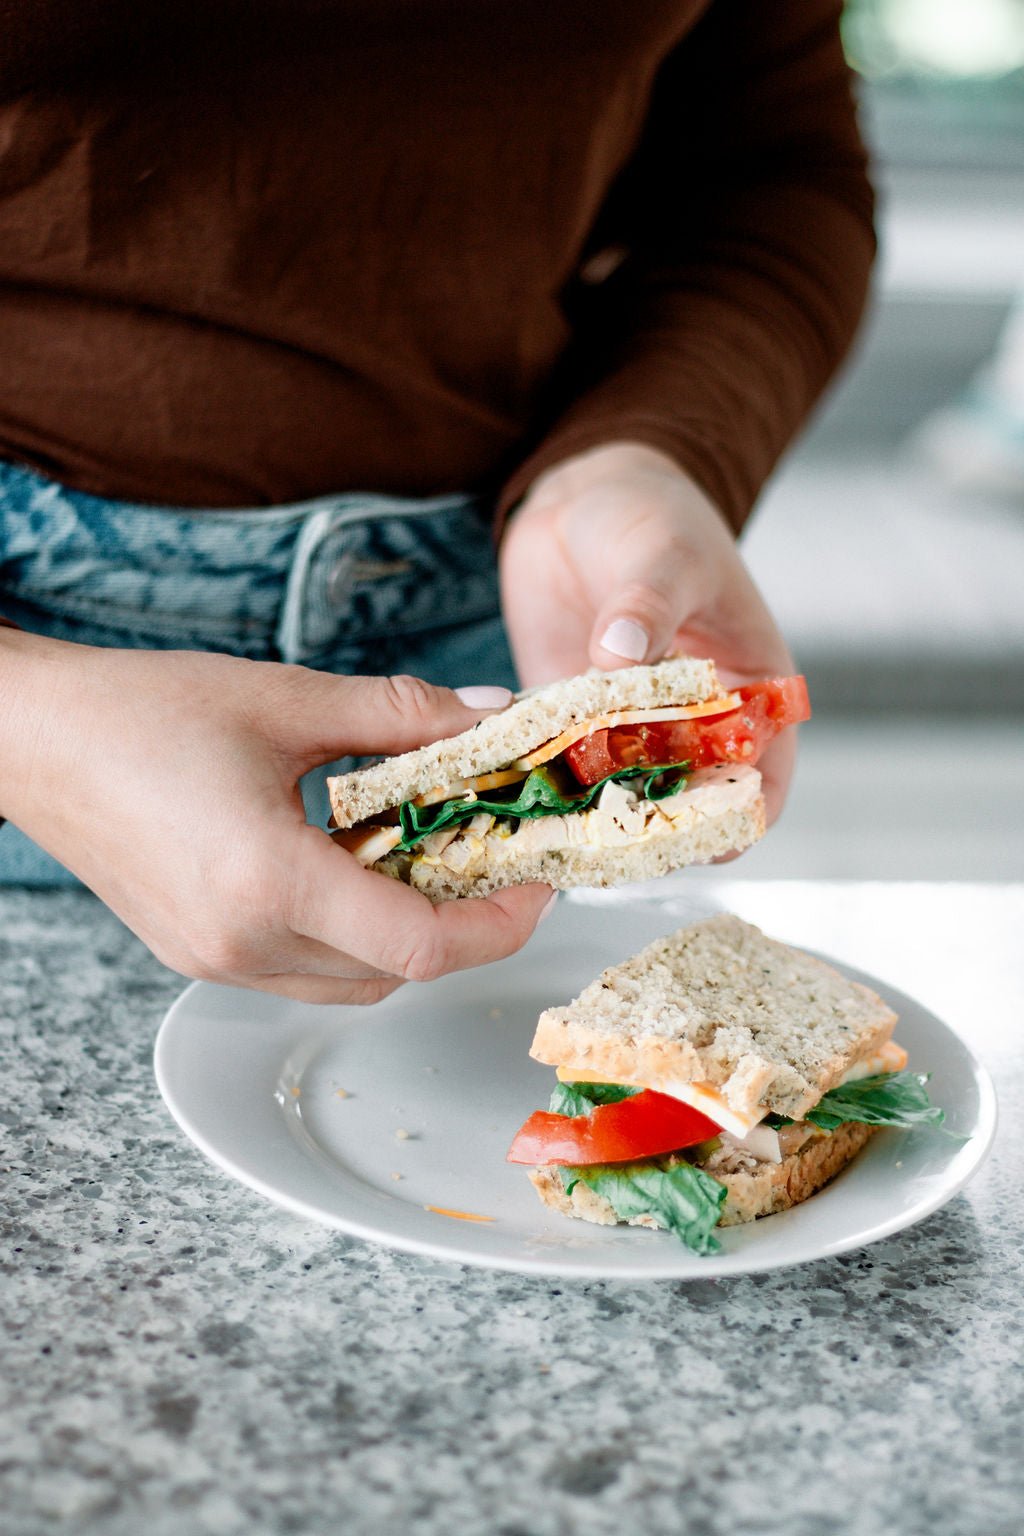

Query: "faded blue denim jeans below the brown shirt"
left=0, top=462, right=516, bottom=885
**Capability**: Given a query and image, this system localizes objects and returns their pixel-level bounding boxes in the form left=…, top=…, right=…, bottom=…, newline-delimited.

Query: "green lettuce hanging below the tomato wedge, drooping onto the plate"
left=562, top=1163, right=726, bottom=1253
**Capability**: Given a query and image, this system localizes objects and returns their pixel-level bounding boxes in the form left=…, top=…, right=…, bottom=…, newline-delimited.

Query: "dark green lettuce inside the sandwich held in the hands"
left=396, top=763, right=688, bottom=851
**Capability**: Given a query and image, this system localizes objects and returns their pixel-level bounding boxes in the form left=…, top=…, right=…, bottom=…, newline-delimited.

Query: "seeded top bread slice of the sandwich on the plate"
left=530, top=912, right=897, bottom=1120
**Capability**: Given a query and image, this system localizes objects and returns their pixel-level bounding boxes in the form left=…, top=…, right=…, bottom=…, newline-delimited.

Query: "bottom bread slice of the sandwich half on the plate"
left=530, top=1123, right=877, bottom=1227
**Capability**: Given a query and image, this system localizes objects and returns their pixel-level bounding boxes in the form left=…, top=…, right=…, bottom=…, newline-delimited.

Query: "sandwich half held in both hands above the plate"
left=327, top=656, right=811, bottom=900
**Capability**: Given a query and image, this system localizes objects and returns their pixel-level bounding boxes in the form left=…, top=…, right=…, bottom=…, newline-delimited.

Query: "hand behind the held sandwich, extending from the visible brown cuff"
left=500, top=442, right=797, bottom=822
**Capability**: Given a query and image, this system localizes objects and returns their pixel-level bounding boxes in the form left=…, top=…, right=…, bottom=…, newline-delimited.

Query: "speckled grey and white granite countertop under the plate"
left=0, top=885, right=1024, bottom=1536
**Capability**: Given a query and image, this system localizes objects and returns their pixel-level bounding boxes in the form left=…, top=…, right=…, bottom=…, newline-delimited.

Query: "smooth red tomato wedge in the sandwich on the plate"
left=508, top=1087, right=722, bottom=1164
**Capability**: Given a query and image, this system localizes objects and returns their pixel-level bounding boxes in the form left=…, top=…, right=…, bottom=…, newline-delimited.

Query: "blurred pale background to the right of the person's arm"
left=706, top=0, right=1024, bottom=880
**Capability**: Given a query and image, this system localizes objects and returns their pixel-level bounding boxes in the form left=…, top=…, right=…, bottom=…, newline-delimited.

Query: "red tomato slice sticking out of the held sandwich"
left=565, top=677, right=811, bottom=783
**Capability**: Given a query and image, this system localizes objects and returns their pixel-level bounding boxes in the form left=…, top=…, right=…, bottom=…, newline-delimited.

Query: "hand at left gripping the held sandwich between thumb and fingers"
left=0, top=630, right=551, bottom=1003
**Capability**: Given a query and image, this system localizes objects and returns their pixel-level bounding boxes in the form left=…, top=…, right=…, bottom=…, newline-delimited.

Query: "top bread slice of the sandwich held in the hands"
left=327, top=656, right=723, bottom=828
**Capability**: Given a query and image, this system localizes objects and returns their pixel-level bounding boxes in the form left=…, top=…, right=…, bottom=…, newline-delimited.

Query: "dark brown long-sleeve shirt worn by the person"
left=0, top=0, right=874, bottom=527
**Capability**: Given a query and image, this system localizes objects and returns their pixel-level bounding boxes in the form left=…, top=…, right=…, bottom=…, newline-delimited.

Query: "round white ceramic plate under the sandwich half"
left=155, top=892, right=996, bottom=1279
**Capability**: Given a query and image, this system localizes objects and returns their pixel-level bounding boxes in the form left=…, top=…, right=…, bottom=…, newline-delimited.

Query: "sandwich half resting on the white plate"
left=508, top=914, right=943, bottom=1253
